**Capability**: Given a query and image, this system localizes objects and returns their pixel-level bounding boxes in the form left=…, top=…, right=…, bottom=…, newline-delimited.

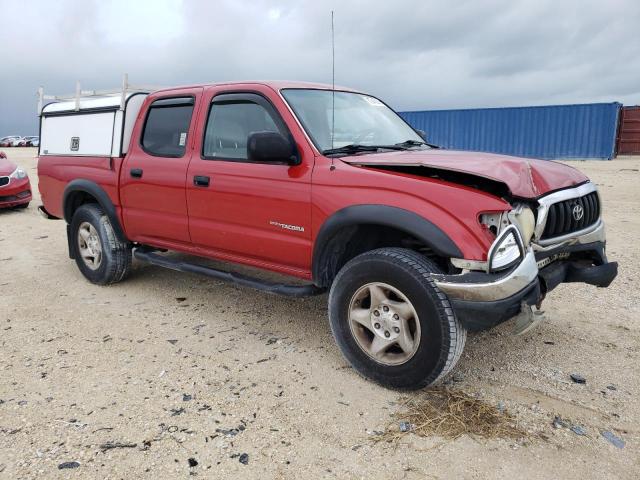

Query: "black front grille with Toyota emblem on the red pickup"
left=541, top=192, right=600, bottom=240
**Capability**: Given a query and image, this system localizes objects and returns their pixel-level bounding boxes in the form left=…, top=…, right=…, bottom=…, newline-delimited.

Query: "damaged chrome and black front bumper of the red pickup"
left=433, top=222, right=618, bottom=331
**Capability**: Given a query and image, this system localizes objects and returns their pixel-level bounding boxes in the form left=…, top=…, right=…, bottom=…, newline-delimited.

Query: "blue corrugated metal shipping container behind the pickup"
left=400, top=103, right=621, bottom=159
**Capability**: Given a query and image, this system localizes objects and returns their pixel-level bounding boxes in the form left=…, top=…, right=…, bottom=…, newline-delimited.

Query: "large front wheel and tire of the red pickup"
left=329, top=248, right=467, bottom=390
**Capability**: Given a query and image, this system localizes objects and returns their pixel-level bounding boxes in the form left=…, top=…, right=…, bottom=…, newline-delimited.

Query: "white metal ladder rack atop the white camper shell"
left=38, top=73, right=163, bottom=116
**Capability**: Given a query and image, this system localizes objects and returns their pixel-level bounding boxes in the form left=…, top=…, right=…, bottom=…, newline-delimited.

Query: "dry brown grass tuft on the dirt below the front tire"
left=380, top=387, right=526, bottom=441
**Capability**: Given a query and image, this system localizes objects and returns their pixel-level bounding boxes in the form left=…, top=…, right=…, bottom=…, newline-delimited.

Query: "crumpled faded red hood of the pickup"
left=341, top=149, right=589, bottom=198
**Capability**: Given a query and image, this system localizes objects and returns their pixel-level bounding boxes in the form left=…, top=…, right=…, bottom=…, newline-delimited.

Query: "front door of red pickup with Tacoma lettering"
left=187, top=86, right=314, bottom=277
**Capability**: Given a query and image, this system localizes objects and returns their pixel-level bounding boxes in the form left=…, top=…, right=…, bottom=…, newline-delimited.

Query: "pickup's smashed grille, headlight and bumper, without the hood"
left=433, top=182, right=618, bottom=333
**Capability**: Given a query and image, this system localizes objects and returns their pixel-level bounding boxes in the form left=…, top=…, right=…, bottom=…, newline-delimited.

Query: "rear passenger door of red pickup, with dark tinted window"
left=120, top=88, right=202, bottom=246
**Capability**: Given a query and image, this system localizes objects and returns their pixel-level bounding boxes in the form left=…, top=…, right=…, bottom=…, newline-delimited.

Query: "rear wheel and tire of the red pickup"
left=69, top=203, right=131, bottom=285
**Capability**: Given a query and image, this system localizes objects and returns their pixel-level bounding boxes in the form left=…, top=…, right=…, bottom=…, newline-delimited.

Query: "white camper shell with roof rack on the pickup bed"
left=38, top=76, right=157, bottom=157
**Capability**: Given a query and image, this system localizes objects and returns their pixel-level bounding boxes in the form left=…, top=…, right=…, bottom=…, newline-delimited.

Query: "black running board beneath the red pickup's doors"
left=133, top=248, right=325, bottom=297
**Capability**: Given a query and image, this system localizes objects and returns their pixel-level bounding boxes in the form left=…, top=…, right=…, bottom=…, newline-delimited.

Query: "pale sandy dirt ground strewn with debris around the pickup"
left=0, top=149, right=640, bottom=479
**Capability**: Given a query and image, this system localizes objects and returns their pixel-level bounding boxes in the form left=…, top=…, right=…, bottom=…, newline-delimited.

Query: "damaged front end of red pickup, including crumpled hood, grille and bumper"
left=344, top=155, right=618, bottom=332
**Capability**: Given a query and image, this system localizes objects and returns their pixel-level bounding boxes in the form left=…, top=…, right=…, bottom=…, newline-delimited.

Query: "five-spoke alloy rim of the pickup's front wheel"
left=349, top=282, right=420, bottom=365
